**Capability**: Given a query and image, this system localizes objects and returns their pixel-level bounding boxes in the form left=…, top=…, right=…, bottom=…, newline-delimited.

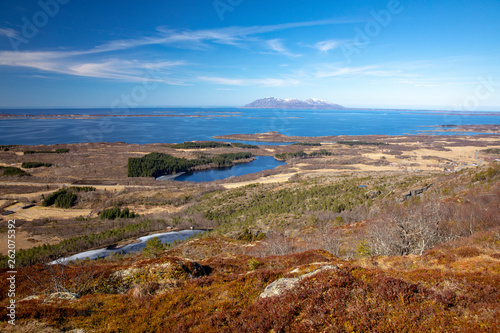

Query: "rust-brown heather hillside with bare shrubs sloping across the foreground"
left=0, top=145, right=500, bottom=333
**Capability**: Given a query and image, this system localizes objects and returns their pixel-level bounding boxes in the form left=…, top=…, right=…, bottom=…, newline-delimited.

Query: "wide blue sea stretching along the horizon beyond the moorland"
left=0, top=108, right=500, bottom=145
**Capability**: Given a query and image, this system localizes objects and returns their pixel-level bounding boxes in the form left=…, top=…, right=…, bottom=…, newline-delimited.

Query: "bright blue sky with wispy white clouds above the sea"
left=0, top=0, right=500, bottom=111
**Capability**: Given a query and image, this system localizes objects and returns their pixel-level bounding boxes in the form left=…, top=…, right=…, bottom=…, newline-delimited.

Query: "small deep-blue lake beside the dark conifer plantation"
left=175, top=156, right=286, bottom=183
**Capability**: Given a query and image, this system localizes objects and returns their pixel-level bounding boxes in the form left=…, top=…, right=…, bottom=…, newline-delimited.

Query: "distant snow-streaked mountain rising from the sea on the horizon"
left=244, top=97, right=345, bottom=110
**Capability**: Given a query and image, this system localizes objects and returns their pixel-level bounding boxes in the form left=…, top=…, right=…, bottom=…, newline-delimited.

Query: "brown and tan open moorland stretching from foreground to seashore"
left=0, top=133, right=500, bottom=332
